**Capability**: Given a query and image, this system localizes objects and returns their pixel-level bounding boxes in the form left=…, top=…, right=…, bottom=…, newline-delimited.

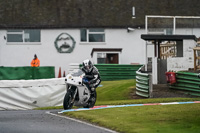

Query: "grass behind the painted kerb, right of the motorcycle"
left=95, top=79, right=200, bottom=105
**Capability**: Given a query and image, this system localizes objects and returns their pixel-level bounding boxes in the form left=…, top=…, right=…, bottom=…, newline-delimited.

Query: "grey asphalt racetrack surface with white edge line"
left=0, top=110, right=114, bottom=133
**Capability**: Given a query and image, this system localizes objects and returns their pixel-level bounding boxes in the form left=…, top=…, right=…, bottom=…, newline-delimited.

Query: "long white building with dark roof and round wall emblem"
left=0, top=0, right=200, bottom=82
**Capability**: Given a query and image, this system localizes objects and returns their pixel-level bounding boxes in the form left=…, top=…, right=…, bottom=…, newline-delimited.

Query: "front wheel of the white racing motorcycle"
left=63, top=90, right=74, bottom=110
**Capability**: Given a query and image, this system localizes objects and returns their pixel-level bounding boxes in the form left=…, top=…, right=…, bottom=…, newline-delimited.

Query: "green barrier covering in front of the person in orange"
left=0, top=67, right=55, bottom=80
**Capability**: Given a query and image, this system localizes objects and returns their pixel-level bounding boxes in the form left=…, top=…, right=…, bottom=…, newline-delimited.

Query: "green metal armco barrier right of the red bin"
left=170, top=71, right=200, bottom=96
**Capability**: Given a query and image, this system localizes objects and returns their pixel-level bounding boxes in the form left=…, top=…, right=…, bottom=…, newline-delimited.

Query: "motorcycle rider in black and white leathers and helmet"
left=81, top=59, right=101, bottom=94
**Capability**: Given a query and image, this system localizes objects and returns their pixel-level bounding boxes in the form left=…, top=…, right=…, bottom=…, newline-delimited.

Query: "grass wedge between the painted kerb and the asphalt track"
left=66, top=104, right=200, bottom=133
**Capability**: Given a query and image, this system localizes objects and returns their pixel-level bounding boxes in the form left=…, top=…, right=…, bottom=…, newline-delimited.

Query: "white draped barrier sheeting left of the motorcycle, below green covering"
left=0, top=78, right=66, bottom=110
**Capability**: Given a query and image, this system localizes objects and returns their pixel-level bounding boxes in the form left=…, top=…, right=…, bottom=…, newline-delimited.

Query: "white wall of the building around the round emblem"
left=0, top=29, right=146, bottom=77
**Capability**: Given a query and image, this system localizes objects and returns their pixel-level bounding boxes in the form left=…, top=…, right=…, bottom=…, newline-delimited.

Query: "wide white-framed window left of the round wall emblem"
left=7, top=29, right=40, bottom=43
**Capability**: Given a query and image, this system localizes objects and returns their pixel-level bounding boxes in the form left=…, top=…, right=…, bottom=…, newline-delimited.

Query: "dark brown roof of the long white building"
left=0, top=0, right=200, bottom=29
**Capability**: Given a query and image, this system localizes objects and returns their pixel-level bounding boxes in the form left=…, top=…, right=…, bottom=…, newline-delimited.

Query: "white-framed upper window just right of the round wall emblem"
left=80, top=29, right=105, bottom=42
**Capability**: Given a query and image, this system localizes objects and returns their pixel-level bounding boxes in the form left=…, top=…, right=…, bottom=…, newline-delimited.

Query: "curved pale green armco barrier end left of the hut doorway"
left=136, top=67, right=153, bottom=98
